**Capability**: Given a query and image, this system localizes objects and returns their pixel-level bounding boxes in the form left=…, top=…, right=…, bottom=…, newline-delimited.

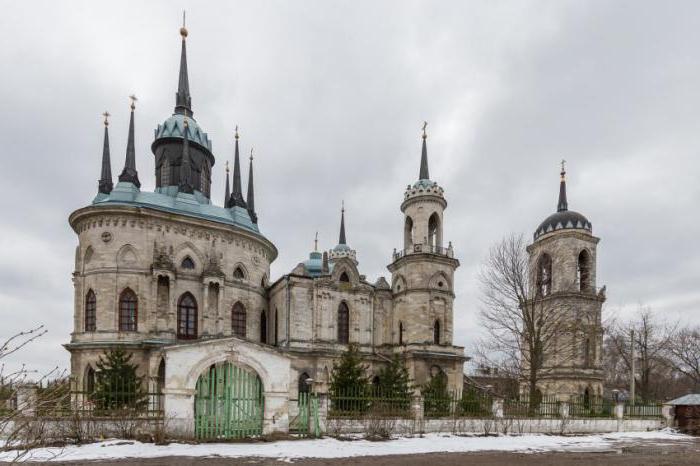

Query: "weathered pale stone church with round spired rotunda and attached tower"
left=65, top=26, right=601, bottom=433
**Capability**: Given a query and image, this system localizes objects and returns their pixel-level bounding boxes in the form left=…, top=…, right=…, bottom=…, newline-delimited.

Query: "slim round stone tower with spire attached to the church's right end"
left=388, top=125, right=464, bottom=389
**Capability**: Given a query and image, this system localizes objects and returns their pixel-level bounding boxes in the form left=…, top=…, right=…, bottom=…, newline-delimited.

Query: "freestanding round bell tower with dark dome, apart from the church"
left=527, top=161, right=605, bottom=398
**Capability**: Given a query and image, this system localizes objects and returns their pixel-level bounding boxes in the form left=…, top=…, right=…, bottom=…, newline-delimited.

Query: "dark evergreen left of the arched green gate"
left=91, top=349, right=148, bottom=411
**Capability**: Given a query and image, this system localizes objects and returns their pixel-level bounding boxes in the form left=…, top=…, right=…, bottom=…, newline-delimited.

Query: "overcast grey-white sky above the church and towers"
left=0, top=0, right=700, bottom=370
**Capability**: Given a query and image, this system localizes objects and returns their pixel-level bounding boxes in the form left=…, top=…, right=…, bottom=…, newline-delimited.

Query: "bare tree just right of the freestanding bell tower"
left=606, top=306, right=674, bottom=400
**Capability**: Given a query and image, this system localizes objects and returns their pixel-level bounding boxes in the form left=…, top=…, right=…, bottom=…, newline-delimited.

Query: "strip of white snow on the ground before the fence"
left=0, top=430, right=694, bottom=462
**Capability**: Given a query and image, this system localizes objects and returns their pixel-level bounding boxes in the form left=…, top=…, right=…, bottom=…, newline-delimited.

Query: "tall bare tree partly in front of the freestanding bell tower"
left=478, top=235, right=576, bottom=405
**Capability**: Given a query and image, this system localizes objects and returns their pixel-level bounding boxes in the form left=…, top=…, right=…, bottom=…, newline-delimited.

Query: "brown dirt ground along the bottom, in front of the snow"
left=42, top=439, right=700, bottom=466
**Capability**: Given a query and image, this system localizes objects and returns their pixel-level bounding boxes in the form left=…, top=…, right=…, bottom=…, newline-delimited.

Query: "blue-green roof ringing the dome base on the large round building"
left=92, top=182, right=260, bottom=235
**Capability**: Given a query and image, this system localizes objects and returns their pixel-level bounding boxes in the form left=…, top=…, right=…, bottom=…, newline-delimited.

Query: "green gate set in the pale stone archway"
left=194, top=362, right=265, bottom=440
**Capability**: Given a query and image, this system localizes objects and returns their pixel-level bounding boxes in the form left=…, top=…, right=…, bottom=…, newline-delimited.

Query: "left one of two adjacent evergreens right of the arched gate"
left=330, top=345, right=368, bottom=411
